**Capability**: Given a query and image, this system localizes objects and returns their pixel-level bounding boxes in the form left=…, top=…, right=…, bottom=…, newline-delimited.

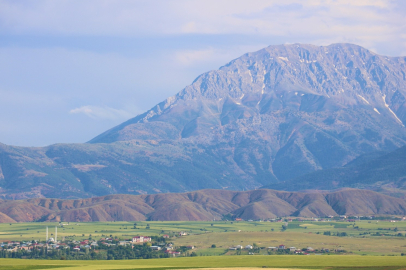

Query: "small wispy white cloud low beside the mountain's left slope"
left=69, top=105, right=133, bottom=120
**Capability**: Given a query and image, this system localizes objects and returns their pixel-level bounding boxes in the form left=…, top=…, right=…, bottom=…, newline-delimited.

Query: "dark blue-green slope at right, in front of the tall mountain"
left=264, top=146, right=406, bottom=198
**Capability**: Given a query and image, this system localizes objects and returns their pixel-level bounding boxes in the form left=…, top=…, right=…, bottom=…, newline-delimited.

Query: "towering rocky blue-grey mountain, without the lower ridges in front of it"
left=90, top=44, right=406, bottom=180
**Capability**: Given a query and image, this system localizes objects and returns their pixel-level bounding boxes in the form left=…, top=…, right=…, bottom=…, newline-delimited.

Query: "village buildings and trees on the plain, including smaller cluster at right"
left=0, top=225, right=345, bottom=260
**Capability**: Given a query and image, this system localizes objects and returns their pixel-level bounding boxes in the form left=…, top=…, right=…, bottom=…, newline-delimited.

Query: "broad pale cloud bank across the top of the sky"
left=0, top=0, right=406, bottom=55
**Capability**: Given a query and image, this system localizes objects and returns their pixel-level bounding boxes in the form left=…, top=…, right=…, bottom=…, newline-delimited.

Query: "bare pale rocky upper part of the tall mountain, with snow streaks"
left=91, top=44, right=406, bottom=142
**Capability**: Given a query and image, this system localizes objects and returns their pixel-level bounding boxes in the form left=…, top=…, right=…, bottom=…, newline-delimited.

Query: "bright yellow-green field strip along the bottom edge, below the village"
left=0, top=255, right=406, bottom=270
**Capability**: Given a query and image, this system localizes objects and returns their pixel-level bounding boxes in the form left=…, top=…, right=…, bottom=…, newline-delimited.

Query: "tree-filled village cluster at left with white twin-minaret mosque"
left=0, top=230, right=196, bottom=259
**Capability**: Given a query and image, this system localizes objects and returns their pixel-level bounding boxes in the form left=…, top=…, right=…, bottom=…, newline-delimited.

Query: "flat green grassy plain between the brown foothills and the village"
left=0, top=220, right=406, bottom=256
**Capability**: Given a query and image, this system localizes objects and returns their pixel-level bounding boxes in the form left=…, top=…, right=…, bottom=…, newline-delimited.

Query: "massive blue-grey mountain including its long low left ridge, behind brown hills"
left=0, top=44, right=406, bottom=199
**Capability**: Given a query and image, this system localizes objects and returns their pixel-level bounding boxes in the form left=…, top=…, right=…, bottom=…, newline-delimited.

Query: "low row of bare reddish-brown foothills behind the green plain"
left=0, top=189, right=406, bottom=223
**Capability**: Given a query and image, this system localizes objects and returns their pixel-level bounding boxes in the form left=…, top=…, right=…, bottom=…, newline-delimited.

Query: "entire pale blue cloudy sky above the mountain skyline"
left=0, top=0, right=406, bottom=146
